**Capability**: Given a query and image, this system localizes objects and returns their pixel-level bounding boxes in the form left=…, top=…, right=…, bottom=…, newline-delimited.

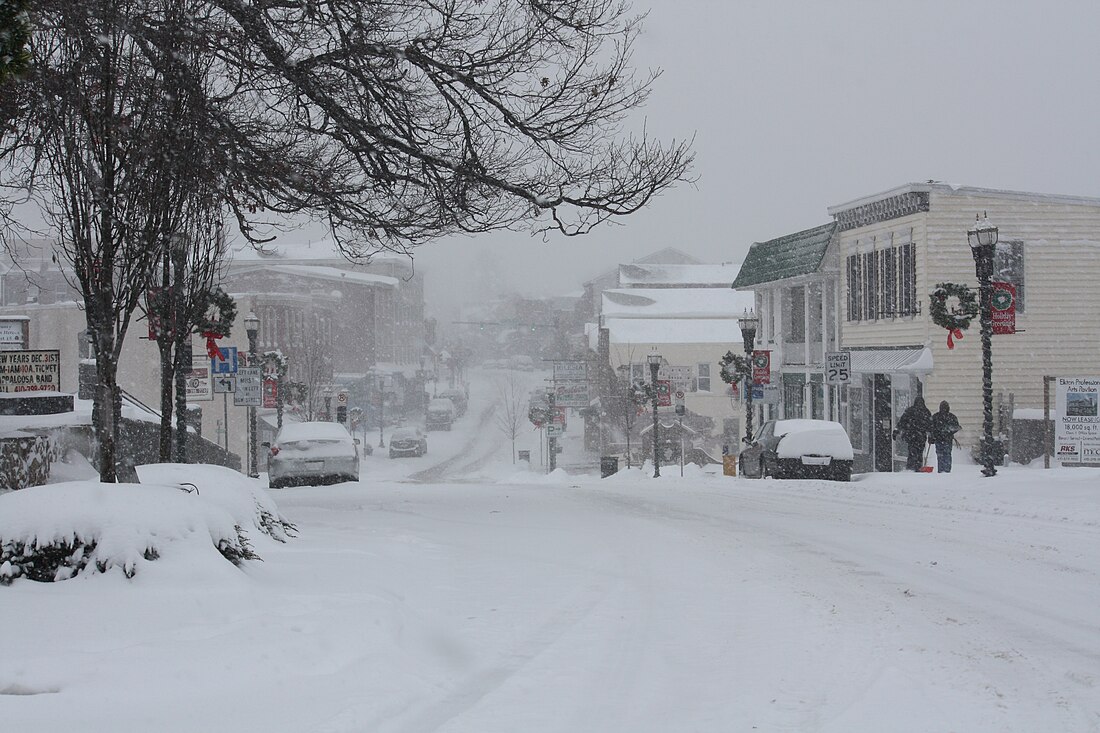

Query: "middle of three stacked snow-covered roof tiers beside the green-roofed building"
left=601, top=287, right=754, bottom=318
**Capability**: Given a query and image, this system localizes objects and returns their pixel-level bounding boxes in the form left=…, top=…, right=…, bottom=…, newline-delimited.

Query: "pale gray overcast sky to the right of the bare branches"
left=417, top=0, right=1100, bottom=315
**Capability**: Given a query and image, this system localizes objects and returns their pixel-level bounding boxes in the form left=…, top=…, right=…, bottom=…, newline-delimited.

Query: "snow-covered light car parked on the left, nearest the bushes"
left=267, top=423, right=359, bottom=489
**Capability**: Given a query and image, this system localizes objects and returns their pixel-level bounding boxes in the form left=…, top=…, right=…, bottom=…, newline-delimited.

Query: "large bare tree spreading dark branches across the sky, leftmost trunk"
left=0, top=0, right=692, bottom=481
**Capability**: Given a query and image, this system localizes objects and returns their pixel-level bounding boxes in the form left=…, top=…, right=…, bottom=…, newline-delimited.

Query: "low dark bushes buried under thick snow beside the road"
left=0, top=464, right=295, bottom=584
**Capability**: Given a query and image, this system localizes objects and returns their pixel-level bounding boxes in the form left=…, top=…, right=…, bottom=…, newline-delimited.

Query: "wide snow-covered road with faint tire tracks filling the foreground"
left=0, top=457, right=1100, bottom=733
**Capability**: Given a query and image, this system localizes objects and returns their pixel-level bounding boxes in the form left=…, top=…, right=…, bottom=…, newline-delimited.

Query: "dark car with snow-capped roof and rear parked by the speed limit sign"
left=737, top=419, right=855, bottom=481
